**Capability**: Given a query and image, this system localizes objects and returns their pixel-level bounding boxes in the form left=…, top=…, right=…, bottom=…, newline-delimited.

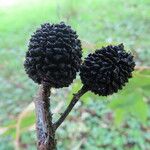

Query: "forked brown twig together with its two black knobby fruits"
left=24, top=22, right=135, bottom=150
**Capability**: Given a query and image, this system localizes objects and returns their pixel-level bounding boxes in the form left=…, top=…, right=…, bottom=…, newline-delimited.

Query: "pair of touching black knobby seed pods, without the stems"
left=24, top=22, right=135, bottom=96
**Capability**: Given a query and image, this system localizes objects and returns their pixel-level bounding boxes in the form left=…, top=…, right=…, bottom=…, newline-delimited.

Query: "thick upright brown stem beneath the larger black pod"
left=34, top=84, right=56, bottom=150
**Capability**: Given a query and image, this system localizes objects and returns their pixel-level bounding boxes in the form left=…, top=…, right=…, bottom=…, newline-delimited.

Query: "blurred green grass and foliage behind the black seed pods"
left=0, top=0, right=150, bottom=150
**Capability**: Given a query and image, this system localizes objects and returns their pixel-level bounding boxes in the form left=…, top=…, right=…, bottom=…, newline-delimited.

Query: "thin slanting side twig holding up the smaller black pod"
left=54, top=86, right=88, bottom=130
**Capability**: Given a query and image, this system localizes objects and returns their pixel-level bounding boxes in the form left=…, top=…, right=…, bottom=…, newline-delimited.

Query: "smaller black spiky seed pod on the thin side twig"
left=80, top=44, right=135, bottom=96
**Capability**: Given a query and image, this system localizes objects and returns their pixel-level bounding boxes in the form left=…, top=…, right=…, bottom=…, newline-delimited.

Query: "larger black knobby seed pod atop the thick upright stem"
left=24, top=22, right=82, bottom=88
